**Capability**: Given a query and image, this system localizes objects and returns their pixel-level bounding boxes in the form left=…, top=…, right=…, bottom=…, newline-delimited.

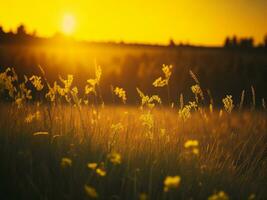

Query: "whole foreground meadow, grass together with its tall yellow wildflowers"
left=0, top=65, right=267, bottom=200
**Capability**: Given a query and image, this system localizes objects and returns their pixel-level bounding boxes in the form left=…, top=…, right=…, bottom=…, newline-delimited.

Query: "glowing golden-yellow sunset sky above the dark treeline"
left=0, top=0, right=267, bottom=45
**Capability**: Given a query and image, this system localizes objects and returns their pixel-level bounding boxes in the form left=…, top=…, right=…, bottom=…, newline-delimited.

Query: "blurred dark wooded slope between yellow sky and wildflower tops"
left=0, top=25, right=267, bottom=105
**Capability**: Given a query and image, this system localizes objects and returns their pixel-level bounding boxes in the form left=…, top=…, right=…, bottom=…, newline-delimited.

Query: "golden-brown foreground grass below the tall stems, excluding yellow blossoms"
left=0, top=105, right=267, bottom=199
